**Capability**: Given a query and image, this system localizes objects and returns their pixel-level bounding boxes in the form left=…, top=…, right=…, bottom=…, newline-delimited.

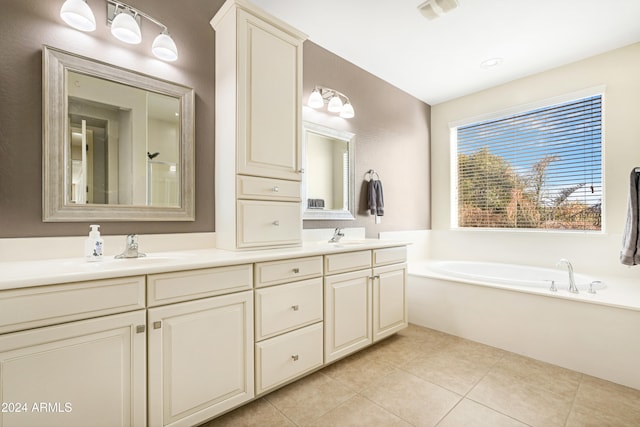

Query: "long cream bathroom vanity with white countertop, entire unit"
left=0, top=240, right=407, bottom=426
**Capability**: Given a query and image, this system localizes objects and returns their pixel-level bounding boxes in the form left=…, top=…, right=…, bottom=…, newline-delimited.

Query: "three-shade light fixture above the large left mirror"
left=60, top=0, right=178, bottom=61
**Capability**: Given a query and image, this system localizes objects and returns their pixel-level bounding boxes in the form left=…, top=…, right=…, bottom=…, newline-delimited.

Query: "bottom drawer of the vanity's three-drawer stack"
left=256, top=323, right=323, bottom=394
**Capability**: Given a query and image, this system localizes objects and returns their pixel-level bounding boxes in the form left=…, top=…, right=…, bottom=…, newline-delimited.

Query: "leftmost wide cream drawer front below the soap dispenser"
left=0, top=276, right=145, bottom=333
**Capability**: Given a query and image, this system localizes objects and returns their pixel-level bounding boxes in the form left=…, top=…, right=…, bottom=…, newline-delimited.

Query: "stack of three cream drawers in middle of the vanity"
left=255, top=256, right=323, bottom=395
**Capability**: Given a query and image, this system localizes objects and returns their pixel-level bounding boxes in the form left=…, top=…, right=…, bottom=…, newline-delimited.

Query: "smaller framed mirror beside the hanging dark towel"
left=302, top=122, right=355, bottom=220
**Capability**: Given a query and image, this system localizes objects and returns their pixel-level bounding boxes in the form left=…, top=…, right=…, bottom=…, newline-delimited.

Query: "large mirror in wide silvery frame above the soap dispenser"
left=43, top=46, right=195, bottom=222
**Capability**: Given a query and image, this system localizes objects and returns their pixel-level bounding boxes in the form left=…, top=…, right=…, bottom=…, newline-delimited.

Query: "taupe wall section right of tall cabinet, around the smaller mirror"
left=303, top=41, right=431, bottom=237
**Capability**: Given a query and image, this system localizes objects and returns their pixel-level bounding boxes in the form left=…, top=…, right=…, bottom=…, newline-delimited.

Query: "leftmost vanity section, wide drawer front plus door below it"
left=0, top=276, right=147, bottom=426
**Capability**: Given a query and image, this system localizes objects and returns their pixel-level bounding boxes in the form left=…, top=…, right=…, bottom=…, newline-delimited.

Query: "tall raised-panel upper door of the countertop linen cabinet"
left=237, top=10, right=302, bottom=181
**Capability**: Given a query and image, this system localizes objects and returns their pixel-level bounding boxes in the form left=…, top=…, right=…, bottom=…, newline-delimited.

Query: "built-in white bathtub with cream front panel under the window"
left=407, top=261, right=640, bottom=389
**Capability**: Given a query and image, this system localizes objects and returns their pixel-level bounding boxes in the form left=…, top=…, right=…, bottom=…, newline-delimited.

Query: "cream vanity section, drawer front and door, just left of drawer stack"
left=147, top=264, right=254, bottom=426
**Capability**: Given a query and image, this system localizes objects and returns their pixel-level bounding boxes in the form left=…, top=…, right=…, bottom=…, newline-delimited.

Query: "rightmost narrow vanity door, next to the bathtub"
left=373, top=264, right=408, bottom=341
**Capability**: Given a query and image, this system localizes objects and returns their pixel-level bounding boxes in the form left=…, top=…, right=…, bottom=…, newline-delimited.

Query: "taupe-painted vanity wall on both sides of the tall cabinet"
left=0, top=0, right=430, bottom=238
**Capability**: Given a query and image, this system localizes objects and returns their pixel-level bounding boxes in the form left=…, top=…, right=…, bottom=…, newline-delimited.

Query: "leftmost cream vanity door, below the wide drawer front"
left=0, top=310, right=146, bottom=426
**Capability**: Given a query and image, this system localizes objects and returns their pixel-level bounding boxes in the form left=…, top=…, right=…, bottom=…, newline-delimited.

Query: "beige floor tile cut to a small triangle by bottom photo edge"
left=438, top=399, right=526, bottom=427
